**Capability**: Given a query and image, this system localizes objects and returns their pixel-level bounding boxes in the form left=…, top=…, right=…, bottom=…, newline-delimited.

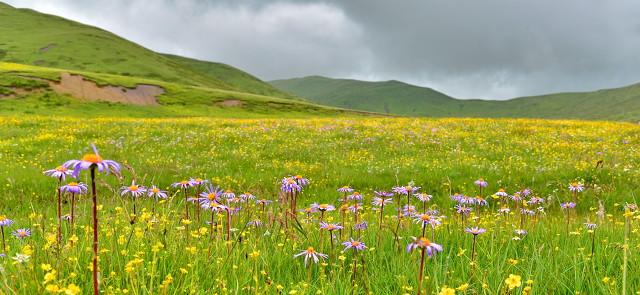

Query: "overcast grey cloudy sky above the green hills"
left=5, top=0, right=640, bottom=99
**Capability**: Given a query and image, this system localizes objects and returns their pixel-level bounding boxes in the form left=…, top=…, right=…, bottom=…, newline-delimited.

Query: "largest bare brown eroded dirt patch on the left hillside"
left=49, top=73, right=164, bottom=105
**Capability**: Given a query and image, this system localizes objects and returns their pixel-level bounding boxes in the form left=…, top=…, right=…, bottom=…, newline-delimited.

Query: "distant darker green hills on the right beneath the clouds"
left=270, top=76, right=640, bottom=121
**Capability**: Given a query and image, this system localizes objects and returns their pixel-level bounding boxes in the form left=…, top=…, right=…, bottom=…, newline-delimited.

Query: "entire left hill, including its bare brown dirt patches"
left=0, top=3, right=362, bottom=117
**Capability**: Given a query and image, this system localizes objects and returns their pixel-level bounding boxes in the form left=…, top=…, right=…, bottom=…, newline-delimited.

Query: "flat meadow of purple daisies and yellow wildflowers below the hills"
left=0, top=116, right=640, bottom=294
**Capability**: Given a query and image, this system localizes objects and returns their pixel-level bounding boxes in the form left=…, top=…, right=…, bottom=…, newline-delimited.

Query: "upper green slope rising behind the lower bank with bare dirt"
left=0, top=3, right=291, bottom=97
